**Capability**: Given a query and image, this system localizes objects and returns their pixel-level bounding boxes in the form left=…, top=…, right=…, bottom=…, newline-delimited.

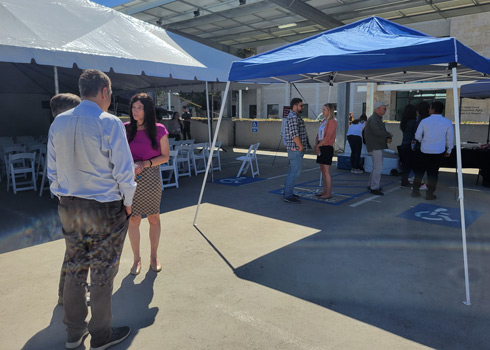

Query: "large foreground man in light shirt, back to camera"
left=47, top=69, right=136, bottom=350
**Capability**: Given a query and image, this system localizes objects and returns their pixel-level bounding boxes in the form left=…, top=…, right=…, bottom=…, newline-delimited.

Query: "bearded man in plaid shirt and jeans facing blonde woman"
left=284, top=98, right=308, bottom=204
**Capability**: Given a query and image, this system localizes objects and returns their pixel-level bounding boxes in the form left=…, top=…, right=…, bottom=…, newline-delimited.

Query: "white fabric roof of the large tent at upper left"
left=0, top=0, right=237, bottom=82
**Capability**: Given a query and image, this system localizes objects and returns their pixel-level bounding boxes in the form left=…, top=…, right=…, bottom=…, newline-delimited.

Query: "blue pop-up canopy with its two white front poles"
left=194, top=17, right=490, bottom=305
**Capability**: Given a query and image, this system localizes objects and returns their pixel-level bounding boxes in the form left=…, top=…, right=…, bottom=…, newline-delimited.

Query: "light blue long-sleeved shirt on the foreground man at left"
left=47, top=100, right=136, bottom=206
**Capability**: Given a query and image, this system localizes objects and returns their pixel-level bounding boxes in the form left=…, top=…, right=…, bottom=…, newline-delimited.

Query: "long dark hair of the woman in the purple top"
left=126, top=92, right=158, bottom=149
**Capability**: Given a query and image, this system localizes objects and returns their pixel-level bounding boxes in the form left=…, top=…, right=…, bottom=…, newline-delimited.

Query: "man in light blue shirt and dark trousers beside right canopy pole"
left=412, top=101, right=454, bottom=200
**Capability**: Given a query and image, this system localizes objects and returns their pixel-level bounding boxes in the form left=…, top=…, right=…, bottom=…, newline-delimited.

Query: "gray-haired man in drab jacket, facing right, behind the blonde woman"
left=364, top=101, right=393, bottom=196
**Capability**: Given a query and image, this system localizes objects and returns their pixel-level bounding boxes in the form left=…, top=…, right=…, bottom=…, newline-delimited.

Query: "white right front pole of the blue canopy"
left=452, top=66, right=471, bottom=306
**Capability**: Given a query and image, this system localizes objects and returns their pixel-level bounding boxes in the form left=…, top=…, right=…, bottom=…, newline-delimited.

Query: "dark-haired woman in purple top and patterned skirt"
left=125, top=93, right=169, bottom=275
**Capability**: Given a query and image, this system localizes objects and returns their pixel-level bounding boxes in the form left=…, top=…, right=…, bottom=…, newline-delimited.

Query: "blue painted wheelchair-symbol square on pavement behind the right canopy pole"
left=398, top=203, right=482, bottom=228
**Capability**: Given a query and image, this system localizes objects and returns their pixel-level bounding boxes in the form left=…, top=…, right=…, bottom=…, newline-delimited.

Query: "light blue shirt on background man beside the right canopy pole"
left=415, top=114, right=454, bottom=154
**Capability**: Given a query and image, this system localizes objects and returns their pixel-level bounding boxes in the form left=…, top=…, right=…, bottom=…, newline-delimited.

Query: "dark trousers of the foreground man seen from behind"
left=58, top=197, right=129, bottom=344
